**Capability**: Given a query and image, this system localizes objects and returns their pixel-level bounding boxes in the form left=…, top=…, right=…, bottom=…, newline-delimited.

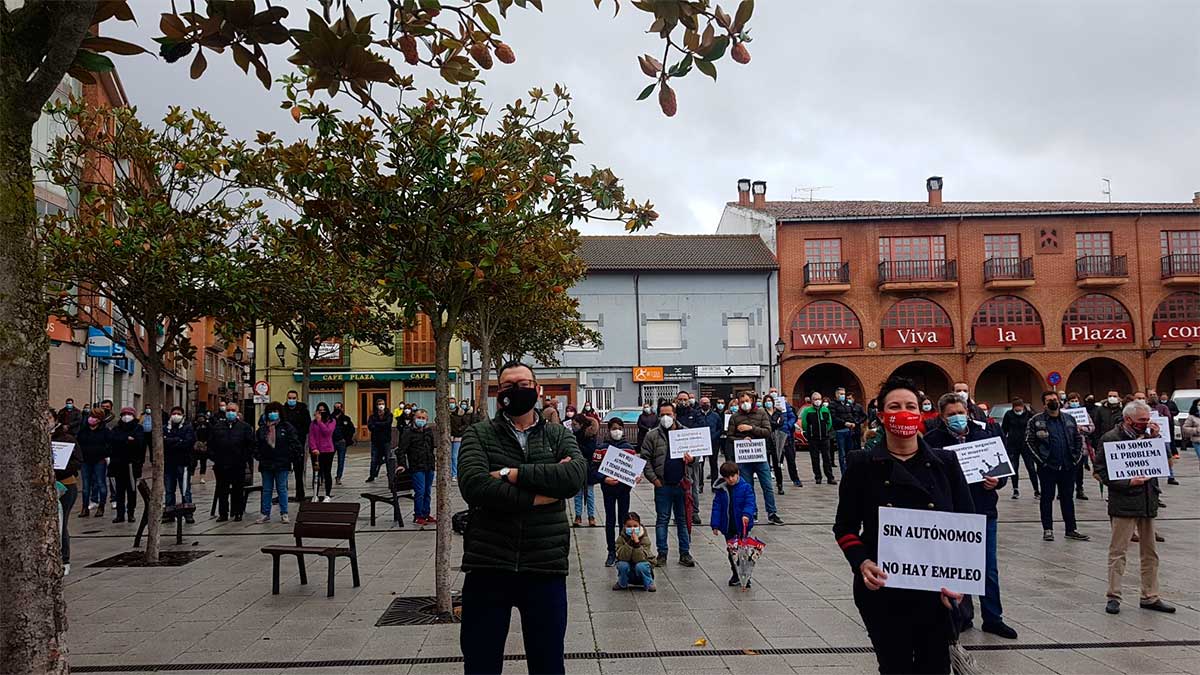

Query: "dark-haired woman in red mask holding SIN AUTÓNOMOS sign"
left=833, top=377, right=974, bottom=673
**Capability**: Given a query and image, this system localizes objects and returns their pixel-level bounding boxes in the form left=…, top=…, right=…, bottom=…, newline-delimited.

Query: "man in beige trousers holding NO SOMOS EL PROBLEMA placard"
left=1096, top=399, right=1175, bottom=614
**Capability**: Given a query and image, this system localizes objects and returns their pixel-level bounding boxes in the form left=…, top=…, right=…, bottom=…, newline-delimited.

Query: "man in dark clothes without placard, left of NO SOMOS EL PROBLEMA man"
left=1025, top=390, right=1091, bottom=542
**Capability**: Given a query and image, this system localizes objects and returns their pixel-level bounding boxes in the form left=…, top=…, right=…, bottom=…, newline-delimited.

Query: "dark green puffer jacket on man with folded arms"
left=458, top=412, right=588, bottom=577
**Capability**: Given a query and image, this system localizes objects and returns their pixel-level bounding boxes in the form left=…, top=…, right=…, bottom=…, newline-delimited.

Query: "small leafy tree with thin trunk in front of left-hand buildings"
left=41, top=100, right=266, bottom=563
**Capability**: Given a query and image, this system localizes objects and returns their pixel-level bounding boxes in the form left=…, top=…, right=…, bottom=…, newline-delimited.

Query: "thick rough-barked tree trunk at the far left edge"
left=0, top=90, right=72, bottom=673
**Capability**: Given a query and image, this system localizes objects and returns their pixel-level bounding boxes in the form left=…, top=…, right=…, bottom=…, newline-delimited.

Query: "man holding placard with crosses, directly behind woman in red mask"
left=925, top=394, right=1016, bottom=640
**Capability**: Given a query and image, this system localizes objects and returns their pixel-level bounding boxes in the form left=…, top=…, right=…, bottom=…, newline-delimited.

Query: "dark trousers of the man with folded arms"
left=460, top=571, right=566, bottom=675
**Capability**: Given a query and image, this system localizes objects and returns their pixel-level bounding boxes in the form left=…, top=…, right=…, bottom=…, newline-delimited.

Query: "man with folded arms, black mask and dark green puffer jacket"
left=458, top=362, right=588, bottom=674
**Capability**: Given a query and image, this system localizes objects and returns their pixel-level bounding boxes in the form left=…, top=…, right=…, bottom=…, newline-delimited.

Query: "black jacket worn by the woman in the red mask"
left=833, top=440, right=974, bottom=571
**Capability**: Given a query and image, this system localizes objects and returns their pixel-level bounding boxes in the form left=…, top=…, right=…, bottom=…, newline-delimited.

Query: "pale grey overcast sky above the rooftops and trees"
left=106, top=0, right=1200, bottom=233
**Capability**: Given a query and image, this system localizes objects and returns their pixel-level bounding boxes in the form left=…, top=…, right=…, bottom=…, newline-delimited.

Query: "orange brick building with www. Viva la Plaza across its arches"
left=718, top=177, right=1200, bottom=402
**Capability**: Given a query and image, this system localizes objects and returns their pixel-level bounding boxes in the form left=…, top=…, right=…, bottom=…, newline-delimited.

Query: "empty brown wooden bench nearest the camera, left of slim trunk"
left=262, top=502, right=360, bottom=598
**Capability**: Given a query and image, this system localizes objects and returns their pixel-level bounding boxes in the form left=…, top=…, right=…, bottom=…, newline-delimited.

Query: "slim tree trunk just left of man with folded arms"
left=431, top=317, right=454, bottom=615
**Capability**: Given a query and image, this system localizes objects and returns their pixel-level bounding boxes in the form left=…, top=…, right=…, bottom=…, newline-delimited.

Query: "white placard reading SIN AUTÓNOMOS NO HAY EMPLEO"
left=880, top=507, right=988, bottom=596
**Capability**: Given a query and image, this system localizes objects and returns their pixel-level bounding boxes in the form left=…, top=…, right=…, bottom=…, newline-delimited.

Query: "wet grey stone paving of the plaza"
left=66, top=449, right=1200, bottom=675
